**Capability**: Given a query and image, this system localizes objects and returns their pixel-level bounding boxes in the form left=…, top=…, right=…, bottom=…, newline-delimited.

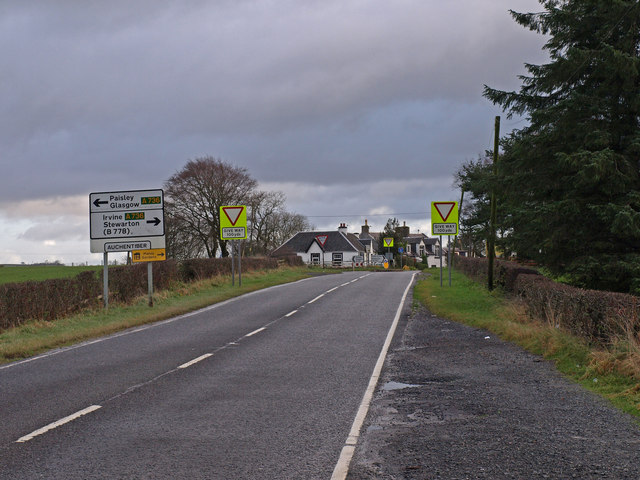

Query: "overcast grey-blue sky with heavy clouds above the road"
left=0, top=0, right=546, bottom=264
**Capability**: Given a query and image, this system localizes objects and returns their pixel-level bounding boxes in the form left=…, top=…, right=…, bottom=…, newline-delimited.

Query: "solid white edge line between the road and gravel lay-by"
left=331, top=273, right=416, bottom=480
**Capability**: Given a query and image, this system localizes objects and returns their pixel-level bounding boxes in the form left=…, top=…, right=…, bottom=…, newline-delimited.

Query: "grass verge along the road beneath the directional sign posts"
left=0, top=267, right=310, bottom=364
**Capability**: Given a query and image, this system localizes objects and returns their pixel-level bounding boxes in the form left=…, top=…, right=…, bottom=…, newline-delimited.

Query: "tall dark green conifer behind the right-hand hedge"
left=484, top=0, right=640, bottom=293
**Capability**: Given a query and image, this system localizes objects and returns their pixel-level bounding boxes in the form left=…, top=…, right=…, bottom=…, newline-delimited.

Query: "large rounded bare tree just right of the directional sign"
left=164, top=157, right=257, bottom=258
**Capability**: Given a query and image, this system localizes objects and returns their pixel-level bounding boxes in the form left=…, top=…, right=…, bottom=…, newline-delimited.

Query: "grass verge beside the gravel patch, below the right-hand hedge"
left=414, top=270, right=640, bottom=419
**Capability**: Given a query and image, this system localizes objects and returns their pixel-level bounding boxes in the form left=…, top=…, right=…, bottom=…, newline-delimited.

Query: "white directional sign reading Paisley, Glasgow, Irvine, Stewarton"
left=89, top=190, right=165, bottom=253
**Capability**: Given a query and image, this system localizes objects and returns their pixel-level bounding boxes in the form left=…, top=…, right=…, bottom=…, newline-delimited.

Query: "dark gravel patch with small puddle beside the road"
left=347, top=309, right=640, bottom=480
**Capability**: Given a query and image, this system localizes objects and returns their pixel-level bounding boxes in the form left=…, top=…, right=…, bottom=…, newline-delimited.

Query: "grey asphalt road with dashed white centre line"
left=0, top=272, right=413, bottom=479
